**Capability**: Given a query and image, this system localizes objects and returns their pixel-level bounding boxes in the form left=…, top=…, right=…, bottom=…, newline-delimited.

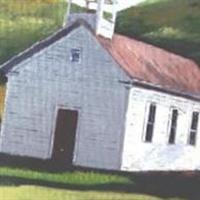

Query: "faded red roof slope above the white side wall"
left=98, top=34, right=200, bottom=96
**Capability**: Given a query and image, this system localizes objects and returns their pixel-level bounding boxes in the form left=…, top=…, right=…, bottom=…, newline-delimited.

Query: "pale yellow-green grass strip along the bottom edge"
left=0, top=186, right=172, bottom=200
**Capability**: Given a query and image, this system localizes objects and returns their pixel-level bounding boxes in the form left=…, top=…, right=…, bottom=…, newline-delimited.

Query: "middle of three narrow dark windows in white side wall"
left=169, top=109, right=178, bottom=144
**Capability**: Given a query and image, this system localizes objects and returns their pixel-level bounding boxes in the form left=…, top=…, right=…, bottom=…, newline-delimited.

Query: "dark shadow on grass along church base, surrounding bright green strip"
left=0, top=155, right=200, bottom=200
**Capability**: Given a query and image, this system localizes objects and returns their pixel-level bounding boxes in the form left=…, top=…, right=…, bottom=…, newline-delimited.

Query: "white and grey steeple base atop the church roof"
left=64, top=0, right=117, bottom=39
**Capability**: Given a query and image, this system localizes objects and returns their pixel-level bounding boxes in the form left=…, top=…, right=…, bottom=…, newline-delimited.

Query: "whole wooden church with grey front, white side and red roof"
left=0, top=0, right=200, bottom=171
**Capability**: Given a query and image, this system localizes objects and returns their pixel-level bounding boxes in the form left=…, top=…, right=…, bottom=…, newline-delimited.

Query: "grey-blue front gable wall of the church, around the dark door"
left=0, top=26, right=128, bottom=170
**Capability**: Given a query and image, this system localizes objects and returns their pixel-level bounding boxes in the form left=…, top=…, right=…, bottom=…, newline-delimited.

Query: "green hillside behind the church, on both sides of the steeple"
left=0, top=0, right=200, bottom=63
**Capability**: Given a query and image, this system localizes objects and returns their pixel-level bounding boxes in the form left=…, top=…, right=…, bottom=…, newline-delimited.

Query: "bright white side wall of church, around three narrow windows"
left=121, top=87, right=200, bottom=171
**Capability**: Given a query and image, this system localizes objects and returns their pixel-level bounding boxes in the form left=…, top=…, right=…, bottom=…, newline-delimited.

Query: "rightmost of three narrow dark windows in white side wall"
left=188, top=112, right=199, bottom=145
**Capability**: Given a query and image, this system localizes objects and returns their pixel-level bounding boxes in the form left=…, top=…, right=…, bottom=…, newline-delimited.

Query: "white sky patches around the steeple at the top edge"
left=69, top=0, right=145, bottom=11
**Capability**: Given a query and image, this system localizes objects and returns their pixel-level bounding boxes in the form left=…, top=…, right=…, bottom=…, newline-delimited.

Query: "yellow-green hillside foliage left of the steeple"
left=0, top=0, right=67, bottom=63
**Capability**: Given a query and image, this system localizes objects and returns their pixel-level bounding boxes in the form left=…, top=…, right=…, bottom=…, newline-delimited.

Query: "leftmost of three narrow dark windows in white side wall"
left=145, top=104, right=156, bottom=142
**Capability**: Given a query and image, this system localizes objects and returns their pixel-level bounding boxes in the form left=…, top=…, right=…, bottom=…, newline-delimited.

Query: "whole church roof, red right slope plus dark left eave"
left=0, top=19, right=200, bottom=97
